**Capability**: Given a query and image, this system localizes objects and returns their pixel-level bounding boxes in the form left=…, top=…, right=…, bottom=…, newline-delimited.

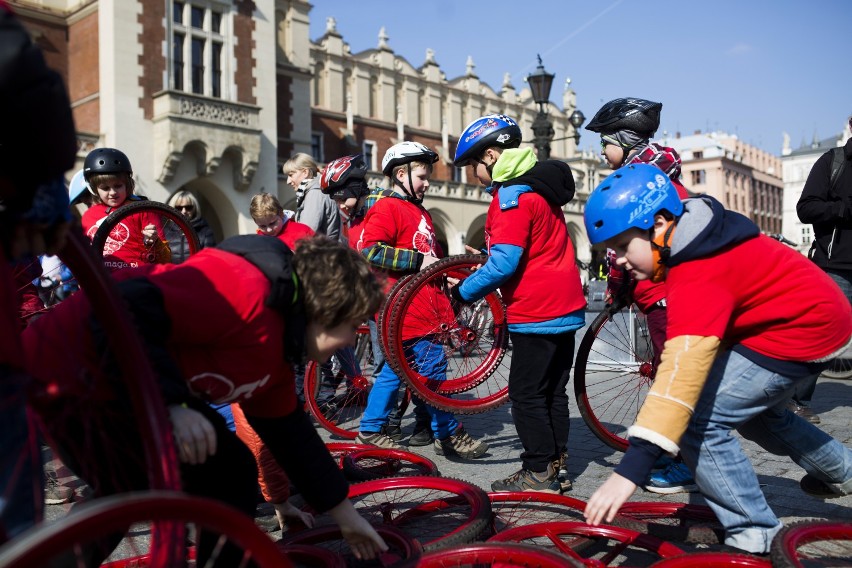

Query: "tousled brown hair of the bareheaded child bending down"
left=293, top=235, right=384, bottom=329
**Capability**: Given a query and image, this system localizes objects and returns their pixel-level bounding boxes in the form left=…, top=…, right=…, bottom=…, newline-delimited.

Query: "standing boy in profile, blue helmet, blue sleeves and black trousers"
left=453, top=115, right=586, bottom=493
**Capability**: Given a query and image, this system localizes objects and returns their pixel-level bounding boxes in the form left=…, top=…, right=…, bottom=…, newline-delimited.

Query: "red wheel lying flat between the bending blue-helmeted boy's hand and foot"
left=612, top=501, right=725, bottom=544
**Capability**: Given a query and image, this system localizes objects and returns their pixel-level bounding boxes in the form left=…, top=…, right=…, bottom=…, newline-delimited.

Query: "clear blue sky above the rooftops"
left=310, top=0, right=852, bottom=154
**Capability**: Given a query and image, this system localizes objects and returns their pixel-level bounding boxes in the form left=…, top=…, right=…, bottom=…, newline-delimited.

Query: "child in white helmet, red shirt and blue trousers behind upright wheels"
left=336, top=141, right=488, bottom=459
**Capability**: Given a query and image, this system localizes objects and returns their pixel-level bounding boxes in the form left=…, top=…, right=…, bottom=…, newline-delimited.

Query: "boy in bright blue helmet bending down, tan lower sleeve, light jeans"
left=584, top=164, right=852, bottom=554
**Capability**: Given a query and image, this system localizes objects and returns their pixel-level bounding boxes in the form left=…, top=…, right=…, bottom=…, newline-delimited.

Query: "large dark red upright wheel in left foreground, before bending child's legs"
left=23, top=227, right=182, bottom=564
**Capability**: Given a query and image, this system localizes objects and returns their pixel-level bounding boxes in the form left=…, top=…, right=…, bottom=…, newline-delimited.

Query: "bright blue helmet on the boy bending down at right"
left=583, top=164, right=683, bottom=245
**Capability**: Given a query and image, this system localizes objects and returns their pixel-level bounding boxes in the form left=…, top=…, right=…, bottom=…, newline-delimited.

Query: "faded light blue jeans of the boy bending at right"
left=681, top=351, right=852, bottom=553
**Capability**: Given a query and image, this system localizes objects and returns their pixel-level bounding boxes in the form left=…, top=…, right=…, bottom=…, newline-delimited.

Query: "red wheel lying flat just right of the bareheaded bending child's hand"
left=342, top=477, right=491, bottom=551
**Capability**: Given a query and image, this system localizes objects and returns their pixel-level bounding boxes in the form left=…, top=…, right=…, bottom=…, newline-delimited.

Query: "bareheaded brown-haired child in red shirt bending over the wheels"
left=23, top=235, right=385, bottom=564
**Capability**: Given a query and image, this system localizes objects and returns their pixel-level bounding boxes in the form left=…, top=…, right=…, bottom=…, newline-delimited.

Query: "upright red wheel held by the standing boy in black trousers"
left=387, top=255, right=509, bottom=414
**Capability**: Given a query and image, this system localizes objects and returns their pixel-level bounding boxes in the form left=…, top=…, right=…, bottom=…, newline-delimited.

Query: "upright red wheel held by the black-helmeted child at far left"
left=89, top=200, right=199, bottom=264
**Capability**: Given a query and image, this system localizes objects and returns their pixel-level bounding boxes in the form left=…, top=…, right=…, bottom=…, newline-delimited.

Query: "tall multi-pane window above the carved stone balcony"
left=171, top=0, right=228, bottom=98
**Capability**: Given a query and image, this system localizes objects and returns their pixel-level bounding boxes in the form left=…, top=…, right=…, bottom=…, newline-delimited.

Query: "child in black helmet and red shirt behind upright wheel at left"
left=82, top=148, right=171, bottom=270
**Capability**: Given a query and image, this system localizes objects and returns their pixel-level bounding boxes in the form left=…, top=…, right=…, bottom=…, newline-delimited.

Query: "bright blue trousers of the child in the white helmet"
left=361, top=338, right=459, bottom=440
